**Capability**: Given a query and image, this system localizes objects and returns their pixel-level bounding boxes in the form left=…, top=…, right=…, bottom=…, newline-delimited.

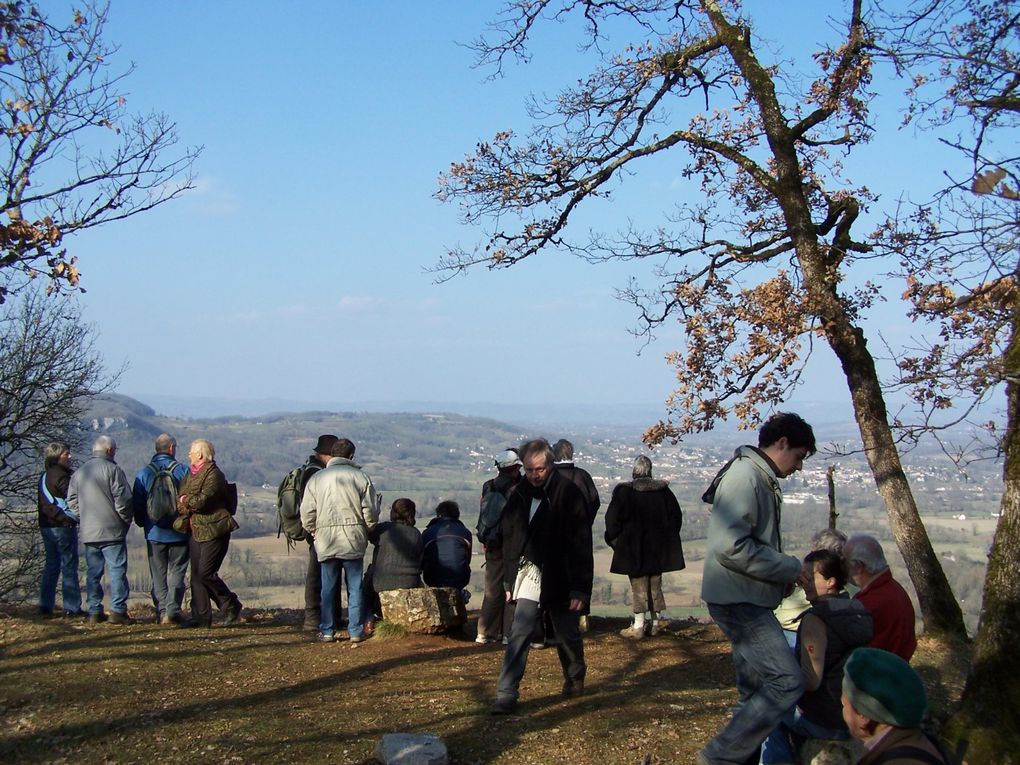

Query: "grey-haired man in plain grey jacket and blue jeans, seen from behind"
left=67, top=436, right=132, bottom=624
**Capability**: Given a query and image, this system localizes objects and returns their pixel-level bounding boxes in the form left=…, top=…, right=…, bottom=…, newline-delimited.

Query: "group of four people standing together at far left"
left=38, top=434, right=242, bottom=627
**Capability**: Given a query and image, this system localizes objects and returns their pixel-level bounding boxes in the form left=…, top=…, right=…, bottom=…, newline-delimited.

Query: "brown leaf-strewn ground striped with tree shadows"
left=0, top=610, right=962, bottom=765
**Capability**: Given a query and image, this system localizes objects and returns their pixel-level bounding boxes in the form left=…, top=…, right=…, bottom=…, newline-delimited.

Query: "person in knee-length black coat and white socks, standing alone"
left=606, top=455, right=684, bottom=640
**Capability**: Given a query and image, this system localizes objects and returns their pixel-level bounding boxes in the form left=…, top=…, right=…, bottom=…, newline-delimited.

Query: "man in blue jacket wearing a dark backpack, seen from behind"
left=132, top=434, right=189, bottom=624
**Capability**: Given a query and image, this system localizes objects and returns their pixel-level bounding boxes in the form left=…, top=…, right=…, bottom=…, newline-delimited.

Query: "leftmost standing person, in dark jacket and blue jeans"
left=37, top=441, right=85, bottom=616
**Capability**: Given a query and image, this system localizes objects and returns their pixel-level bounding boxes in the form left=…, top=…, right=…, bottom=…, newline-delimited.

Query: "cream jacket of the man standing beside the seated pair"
left=301, top=457, right=379, bottom=561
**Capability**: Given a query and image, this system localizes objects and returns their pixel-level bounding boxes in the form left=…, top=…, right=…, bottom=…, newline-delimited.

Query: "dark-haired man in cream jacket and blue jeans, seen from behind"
left=301, top=439, right=379, bottom=643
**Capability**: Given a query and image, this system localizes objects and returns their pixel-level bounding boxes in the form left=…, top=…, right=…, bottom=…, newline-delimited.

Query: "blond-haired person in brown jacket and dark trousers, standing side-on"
left=174, top=439, right=241, bottom=627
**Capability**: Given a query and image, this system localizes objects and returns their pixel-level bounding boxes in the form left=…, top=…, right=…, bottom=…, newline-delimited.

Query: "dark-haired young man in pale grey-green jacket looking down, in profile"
left=698, top=412, right=815, bottom=765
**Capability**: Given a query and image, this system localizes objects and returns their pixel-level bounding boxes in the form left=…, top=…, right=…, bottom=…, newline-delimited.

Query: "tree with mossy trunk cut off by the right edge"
left=883, top=0, right=1020, bottom=763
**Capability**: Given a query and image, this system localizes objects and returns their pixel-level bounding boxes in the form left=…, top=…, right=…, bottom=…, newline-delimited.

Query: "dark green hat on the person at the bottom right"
left=843, top=648, right=928, bottom=728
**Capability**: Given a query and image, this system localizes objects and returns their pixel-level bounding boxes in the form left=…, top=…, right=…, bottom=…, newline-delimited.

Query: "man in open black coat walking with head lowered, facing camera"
left=492, top=440, right=595, bottom=714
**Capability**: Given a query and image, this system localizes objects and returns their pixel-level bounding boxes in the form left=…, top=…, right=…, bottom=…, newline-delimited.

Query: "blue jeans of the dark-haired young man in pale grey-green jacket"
left=702, top=603, right=804, bottom=764
